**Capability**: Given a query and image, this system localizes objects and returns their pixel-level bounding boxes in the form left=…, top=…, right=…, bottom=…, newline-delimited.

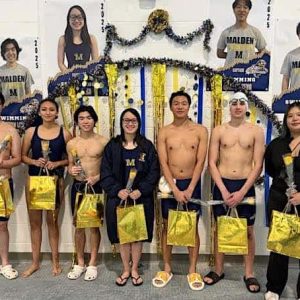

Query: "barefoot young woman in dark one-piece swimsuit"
left=22, top=99, right=71, bottom=277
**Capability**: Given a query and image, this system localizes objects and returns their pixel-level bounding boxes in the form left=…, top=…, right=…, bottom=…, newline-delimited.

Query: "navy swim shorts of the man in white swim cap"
left=213, top=178, right=256, bottom=226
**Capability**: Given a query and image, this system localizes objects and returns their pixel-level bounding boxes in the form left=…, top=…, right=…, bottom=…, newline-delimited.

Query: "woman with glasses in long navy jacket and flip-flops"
left=100, top=108, right=160, bottom=286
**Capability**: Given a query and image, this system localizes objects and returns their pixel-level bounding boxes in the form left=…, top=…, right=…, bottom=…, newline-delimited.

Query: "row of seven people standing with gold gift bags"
left=0, top=87, right=300, bottom=299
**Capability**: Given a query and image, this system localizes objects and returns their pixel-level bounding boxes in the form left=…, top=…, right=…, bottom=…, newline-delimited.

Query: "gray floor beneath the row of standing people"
left=0, top=255, right=299, bottom=300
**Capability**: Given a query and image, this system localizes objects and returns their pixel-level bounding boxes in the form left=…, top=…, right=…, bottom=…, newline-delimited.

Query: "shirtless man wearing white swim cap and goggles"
left=204, top=92, right=265, bottom=293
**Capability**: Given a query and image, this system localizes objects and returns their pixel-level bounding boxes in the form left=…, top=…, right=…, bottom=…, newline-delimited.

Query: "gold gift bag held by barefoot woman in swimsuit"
left=29, top=168, right=57, bottom=210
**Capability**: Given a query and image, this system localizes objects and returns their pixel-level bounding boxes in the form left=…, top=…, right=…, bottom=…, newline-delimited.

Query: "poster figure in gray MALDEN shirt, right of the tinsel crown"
left=217, top=0, right=266, bottom=67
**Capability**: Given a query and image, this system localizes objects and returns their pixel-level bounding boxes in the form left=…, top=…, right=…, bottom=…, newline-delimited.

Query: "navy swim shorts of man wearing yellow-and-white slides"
left=161, top=179, right=201, bottom=220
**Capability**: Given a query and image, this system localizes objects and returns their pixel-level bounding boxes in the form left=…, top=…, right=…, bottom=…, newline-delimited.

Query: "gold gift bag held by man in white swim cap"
left=217, top=208, right=248, bottom=254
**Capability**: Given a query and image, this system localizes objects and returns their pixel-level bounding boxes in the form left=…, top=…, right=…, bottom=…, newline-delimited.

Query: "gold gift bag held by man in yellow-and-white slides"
left=167, top=206, right=197, bottom=247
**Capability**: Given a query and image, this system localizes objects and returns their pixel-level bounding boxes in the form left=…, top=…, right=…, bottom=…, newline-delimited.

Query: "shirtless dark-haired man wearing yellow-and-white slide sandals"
left=152, top=91, right=208, bottom=290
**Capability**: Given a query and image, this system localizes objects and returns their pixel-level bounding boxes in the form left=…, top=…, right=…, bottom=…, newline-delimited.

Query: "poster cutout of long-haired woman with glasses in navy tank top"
left=57, top=5, right=99, bottom=72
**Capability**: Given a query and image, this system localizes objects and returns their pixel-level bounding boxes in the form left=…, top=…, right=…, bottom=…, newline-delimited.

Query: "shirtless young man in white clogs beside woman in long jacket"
left=67, top=106, right=107, bottom=281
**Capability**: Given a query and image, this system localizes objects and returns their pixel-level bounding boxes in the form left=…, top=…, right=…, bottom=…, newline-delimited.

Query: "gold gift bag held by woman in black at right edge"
left=267, top=204, right=300, bottom=259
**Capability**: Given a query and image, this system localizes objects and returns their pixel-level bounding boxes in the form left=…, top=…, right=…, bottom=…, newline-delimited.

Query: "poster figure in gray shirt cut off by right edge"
left=280, top=23, right=300, bottom=92
